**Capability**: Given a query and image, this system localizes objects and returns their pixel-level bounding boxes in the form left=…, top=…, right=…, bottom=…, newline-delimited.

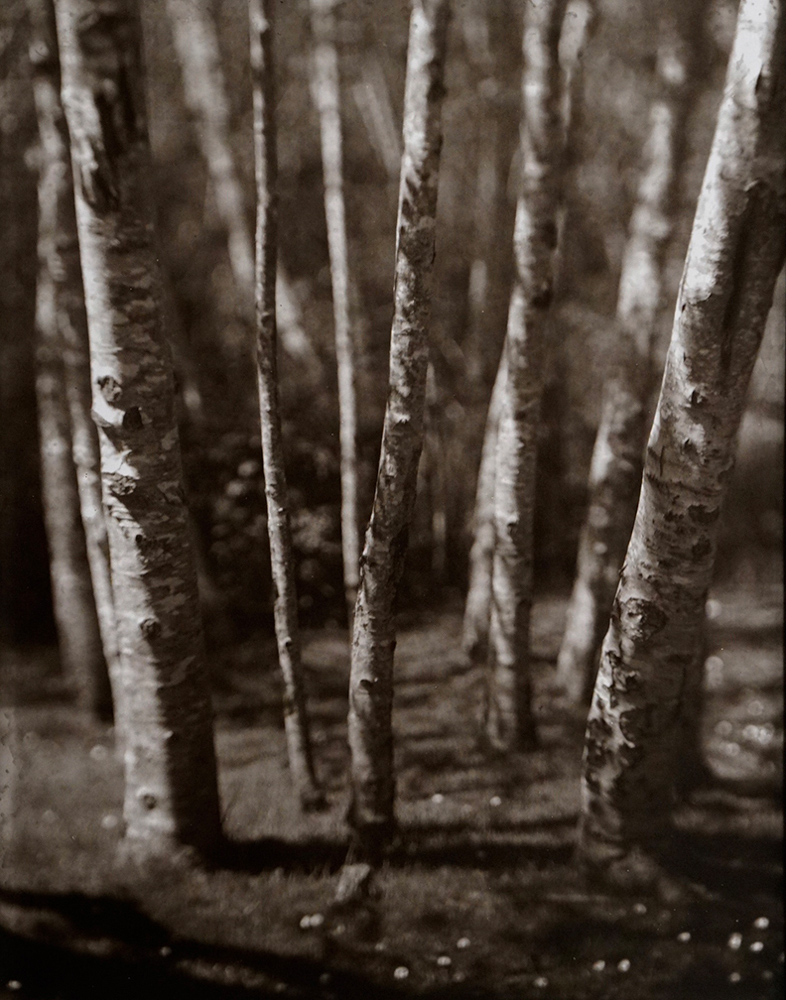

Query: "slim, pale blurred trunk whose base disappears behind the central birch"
left=311, top=0, right=360, bottom=627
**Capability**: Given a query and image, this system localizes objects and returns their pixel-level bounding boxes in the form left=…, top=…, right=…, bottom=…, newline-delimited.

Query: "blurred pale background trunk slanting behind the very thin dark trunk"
left=166, top=0, right=316, bottom=372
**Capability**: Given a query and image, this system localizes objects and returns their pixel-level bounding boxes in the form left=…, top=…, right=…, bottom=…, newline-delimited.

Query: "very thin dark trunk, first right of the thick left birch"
left=249, top=0, right=324, bottom=808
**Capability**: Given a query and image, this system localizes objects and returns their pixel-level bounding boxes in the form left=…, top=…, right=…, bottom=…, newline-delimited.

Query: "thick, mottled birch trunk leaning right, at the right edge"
left=580, top=0, right=786, bottom=879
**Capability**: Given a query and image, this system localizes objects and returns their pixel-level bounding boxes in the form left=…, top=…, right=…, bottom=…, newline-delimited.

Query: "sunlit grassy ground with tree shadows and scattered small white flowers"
left=0, top=581, right=784, bottom=1000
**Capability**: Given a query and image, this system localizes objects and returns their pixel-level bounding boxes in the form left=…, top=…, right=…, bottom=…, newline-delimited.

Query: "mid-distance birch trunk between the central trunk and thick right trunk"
left=486, top=0, right=565, bottom=750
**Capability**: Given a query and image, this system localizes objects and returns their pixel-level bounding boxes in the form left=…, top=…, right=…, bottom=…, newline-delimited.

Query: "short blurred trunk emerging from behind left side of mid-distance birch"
left=462, top=354, right=507, bottom=663
